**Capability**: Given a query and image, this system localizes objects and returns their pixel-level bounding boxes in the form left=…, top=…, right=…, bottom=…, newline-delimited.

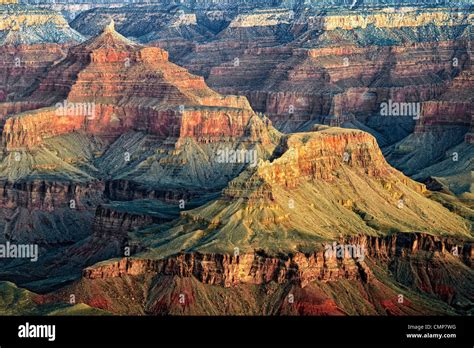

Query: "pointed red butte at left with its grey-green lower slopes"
left=0, top=24, right=280, bottom=220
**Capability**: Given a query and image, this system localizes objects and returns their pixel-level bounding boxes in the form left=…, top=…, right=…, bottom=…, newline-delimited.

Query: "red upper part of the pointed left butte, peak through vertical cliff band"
left=2, top=22, right=260, bottom=150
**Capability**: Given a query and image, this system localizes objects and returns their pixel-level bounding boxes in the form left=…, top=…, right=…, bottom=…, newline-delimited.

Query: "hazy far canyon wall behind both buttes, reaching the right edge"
left=64, top=1, right=472, bottom=194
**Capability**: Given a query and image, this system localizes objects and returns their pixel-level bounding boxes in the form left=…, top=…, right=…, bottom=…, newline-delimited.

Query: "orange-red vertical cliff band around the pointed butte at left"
left=2, top=104, right=260, bottom=151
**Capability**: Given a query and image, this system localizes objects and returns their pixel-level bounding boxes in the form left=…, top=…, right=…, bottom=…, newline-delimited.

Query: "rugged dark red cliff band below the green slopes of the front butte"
left=83, top=233, right=474, bottom=287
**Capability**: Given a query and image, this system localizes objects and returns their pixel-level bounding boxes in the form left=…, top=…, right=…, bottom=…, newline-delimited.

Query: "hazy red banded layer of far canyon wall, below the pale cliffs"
left=206, top=42, right=467, bottom=126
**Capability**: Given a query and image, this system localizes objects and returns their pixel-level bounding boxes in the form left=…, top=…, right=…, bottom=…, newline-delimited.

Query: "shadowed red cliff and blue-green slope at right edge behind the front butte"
left=386, top=62, right=474, bottom=194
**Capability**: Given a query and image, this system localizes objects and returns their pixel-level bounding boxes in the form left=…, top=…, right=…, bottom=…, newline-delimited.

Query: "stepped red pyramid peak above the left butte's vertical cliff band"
left=21, top=20, right=217, bottom=105
